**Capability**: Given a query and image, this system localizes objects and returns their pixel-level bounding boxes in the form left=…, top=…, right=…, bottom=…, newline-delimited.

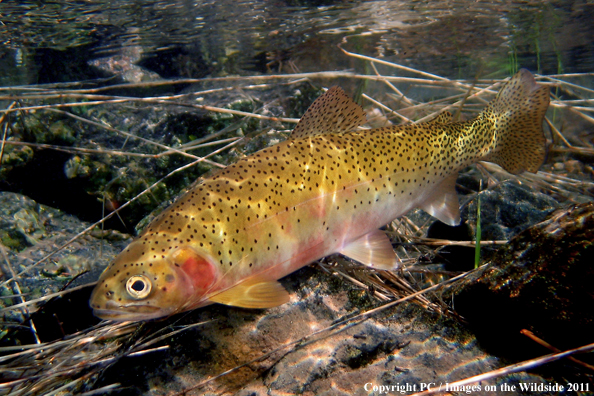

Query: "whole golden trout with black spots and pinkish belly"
left=91, top=70, right=549, bottom=320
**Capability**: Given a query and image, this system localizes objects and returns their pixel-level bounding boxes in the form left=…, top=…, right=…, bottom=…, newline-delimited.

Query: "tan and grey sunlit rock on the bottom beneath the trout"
left=96, top=267, right=573, bottom=396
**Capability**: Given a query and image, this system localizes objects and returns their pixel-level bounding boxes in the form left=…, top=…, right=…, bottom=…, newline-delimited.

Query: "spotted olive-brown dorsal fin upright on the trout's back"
left=290, top=86, right=367, bottom=139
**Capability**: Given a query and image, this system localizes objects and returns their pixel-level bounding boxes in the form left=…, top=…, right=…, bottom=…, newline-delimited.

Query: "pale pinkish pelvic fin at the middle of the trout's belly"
left=340, top=230, right=400, bottom=270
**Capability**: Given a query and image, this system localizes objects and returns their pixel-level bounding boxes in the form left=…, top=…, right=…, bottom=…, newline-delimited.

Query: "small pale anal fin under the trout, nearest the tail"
left=419, top=173, right=460, bottom=226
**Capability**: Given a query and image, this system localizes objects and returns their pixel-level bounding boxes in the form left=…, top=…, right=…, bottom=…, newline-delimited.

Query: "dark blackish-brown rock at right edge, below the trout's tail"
left=445, top=203, right=594, bottom=366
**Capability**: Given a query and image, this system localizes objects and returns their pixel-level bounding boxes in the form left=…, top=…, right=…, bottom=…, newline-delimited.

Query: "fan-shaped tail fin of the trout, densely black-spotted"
left=482, top=69, right=549, bottom=174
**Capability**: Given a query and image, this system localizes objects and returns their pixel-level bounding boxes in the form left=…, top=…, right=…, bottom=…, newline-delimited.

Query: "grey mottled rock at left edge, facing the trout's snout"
left=0, top=192, right=130, bottom=346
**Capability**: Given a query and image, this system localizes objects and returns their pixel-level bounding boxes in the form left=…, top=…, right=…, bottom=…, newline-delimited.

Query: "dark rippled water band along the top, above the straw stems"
left=0, top=0, right=594, bottom=86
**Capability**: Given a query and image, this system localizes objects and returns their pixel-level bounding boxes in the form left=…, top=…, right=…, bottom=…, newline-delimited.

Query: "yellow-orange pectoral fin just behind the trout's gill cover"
left=208, top=279, right=289, bottom=308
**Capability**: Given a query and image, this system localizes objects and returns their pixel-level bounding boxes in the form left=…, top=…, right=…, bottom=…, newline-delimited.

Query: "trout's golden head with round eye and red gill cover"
left=90, top=240, right=216, bottom=321
